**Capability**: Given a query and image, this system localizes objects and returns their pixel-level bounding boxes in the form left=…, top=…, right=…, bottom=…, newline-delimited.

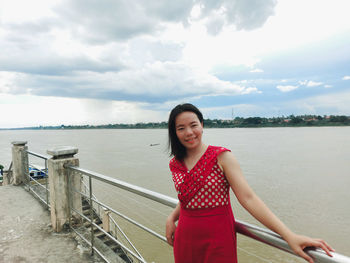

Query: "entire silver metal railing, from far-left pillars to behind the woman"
left=22, top=151, right=350, bottom=263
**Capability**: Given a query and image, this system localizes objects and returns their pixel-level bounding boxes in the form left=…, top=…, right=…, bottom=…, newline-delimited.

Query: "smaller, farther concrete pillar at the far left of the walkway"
left=12, top=141, right=29, bottom=185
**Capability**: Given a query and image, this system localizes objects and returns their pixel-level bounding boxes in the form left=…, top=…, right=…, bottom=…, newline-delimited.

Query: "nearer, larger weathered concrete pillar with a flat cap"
left=47, top=146, right=82, bottom=232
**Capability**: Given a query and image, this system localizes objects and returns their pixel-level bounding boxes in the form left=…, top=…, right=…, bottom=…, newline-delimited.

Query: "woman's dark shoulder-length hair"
left=168, top=103, right=203, bottom=160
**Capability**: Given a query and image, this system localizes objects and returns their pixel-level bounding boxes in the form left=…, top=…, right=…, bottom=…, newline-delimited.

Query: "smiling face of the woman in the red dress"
left=175, top=111, right=203, bottom=152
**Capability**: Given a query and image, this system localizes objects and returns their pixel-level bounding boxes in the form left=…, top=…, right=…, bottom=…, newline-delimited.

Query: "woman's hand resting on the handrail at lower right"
left=286, top=234, right=334, bottom=263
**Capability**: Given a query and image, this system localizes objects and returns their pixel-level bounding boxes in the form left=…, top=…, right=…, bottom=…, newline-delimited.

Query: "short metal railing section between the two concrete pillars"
left=27, top=151, right=50, bottom=210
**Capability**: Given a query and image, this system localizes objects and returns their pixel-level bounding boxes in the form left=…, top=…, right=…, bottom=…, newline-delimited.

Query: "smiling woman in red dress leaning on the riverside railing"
left=166, top=103, right=334, bottom=263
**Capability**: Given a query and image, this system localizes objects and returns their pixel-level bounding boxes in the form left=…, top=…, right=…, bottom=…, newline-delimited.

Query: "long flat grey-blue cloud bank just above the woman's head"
left=4, top=62, right=246, bottom=102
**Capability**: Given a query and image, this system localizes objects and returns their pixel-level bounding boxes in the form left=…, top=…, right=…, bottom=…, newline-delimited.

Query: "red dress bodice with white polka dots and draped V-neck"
left=169, top=146, right=230, bottom=209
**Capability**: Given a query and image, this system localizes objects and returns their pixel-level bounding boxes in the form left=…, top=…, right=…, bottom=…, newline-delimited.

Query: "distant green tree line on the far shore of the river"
left=5, top=115, right=350, bottom=130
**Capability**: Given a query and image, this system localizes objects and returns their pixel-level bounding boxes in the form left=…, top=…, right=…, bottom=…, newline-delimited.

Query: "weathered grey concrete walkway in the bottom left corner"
left=0, top=185, right=102, bottom=263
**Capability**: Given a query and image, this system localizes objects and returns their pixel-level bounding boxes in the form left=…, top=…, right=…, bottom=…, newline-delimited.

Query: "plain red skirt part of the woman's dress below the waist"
left=174, top=205, right=237, bottom=263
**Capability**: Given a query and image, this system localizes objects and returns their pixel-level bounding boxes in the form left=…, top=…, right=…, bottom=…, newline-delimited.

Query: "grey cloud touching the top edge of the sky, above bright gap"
left=50, top=0, right=276, bottom=43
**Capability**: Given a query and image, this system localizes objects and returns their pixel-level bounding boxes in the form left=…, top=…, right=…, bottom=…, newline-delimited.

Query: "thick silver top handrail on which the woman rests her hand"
left=68, top=166, right=350, bottom=263
